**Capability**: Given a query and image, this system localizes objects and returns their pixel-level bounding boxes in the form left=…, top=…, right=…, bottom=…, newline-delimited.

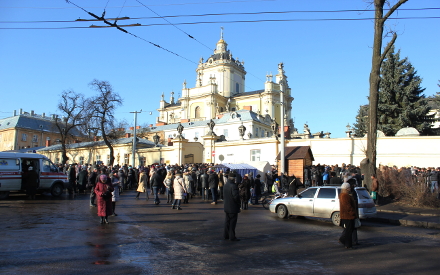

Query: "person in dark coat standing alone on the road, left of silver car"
left=223, top=172, right=240, bottom=241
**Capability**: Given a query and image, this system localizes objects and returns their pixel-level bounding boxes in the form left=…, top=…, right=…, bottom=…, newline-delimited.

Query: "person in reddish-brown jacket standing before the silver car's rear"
left=339, top=182, right=356, bottom=248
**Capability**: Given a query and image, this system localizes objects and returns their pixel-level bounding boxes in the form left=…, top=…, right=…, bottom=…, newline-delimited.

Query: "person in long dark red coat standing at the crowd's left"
left=95, top=174, right=114, bottom=224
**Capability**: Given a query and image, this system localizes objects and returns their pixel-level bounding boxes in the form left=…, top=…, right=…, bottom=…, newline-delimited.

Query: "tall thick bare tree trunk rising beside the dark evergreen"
left=363, top=0, right=408, bottom=191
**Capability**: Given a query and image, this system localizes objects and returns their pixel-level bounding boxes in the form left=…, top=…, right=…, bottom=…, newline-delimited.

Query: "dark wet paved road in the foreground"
left=0, top=191, right=440, bottom=274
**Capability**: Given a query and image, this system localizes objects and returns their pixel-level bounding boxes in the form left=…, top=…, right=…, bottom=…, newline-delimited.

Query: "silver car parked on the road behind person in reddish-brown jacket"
left=269, top=186, right=377, bottom=226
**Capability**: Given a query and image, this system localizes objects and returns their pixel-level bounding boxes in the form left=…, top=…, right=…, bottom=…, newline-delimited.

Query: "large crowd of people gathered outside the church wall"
left=56, top=163, right=440, bottom=245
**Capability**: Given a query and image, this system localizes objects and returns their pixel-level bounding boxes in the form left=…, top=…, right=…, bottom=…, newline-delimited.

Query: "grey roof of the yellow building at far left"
left=0, top=113, right=81, bottom=136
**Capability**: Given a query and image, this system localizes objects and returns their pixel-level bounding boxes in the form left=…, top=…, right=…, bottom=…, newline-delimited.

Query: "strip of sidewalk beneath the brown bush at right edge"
left=369, top=203, right=440, bottom=229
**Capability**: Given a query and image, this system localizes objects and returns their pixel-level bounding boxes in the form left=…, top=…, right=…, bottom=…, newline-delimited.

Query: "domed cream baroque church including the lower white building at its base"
left=155, top=32, right=293, bottom=140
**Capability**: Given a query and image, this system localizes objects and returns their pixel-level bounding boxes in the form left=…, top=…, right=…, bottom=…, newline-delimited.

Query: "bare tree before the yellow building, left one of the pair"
left=55, top=90, right=87, bottom=165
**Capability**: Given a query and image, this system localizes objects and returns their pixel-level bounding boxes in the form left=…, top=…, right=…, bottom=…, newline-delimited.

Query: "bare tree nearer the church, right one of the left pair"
left=89, top=79, right=123, bottom=166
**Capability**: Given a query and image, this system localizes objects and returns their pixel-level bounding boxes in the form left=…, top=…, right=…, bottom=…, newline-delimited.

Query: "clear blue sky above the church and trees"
left=0, top=0, right=440, bottom=138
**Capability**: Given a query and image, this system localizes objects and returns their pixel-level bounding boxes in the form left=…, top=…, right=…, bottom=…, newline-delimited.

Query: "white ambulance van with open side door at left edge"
left=0, top=152, right=68, bottom=199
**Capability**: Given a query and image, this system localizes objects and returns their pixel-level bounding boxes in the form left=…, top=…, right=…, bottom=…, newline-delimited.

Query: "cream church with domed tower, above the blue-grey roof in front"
left=156, top=32, right=293, bottom=132
